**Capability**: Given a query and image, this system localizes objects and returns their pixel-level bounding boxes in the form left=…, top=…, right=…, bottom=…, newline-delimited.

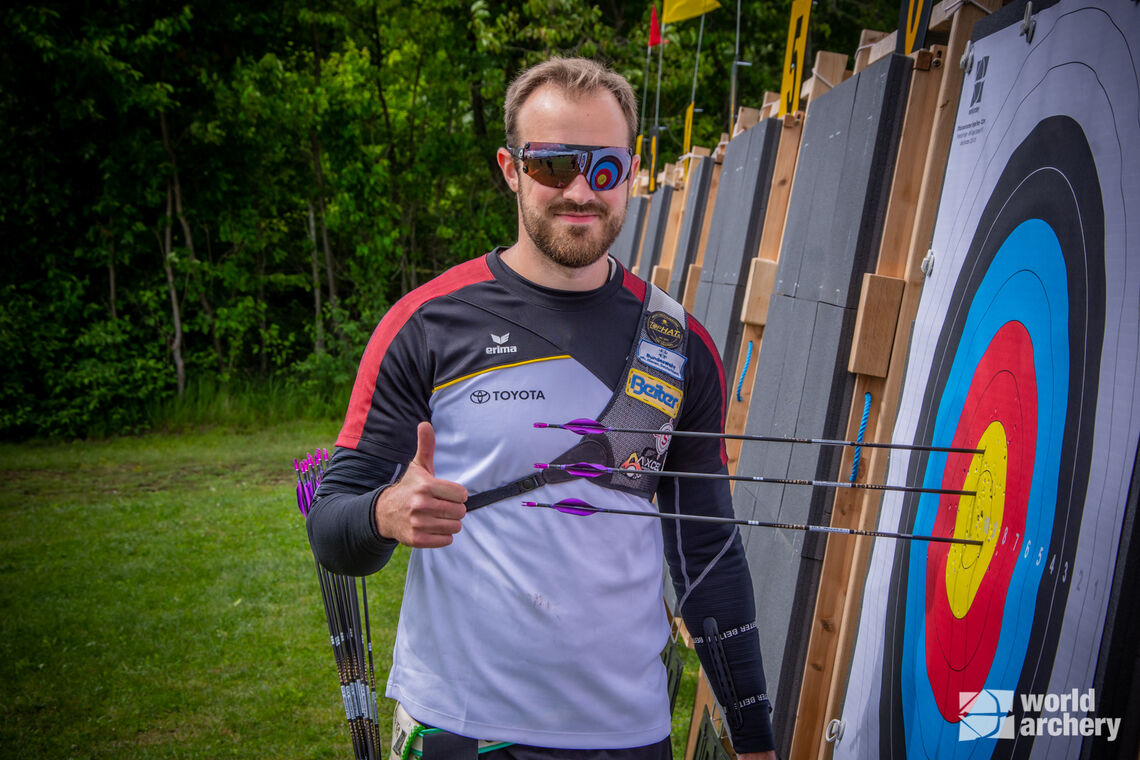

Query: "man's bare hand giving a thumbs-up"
left=373, top=422, right=467, bottom=549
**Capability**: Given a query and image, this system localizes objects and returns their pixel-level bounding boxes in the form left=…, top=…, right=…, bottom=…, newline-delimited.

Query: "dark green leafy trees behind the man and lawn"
left=0, top=0, right=897, bottom=439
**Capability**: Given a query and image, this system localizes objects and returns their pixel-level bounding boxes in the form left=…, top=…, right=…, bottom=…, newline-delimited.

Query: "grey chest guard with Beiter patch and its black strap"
left=467, top=284, right=689, bottom=512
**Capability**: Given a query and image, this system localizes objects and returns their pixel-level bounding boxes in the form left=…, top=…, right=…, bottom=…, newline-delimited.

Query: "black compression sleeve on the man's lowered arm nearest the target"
left=657, top=468, right=775, bottom=753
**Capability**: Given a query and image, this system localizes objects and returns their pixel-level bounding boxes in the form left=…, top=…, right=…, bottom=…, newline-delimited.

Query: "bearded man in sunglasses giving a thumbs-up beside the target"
left=308, top=58, right=775, bottom=760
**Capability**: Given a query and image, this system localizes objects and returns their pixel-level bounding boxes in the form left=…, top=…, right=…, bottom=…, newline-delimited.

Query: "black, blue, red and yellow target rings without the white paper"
left=896, top=116, right=1105, bottom=757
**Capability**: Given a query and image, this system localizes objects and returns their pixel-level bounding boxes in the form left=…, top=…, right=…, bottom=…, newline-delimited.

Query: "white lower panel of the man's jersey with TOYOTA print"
left=388, top=359, right=670, bottom=749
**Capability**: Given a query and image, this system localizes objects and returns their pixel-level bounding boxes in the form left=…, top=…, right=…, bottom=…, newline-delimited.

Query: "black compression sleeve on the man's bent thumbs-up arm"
left=306, top=449, right=400, bottom=575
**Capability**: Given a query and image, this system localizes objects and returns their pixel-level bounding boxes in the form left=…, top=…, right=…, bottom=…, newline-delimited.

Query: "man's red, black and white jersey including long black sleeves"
left=309, top=252, right=771, bottom=751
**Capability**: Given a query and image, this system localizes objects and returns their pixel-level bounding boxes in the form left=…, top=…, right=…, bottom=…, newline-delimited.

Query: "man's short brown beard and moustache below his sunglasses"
left=519, top=193, right=626, bottom=269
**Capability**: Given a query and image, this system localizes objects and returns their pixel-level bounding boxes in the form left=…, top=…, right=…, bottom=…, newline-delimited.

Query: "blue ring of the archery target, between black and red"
left=903, top=219, right=1069, bottom=757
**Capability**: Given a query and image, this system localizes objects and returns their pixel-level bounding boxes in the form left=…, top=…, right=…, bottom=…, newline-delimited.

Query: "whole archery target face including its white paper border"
left=834, top=2, right=1140, bottom=759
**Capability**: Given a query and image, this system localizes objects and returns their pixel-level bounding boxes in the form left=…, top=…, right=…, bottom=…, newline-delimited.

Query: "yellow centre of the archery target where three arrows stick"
left=946, top=422, right=1009, bottom=620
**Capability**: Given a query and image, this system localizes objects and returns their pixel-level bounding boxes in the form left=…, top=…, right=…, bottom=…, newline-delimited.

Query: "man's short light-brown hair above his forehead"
left=503, top=58, right=637, bottom=147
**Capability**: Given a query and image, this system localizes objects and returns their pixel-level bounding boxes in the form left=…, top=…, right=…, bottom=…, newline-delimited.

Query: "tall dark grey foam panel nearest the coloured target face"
left=733, top=56, right=912, bottom=752
